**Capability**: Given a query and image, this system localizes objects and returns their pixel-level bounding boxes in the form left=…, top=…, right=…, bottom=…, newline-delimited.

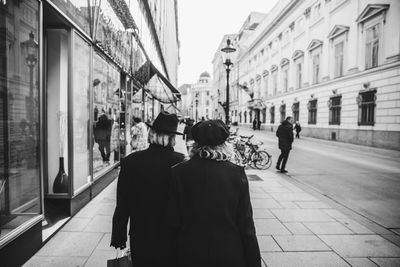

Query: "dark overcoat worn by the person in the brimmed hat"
left=111, top=144, right=184, bottom=267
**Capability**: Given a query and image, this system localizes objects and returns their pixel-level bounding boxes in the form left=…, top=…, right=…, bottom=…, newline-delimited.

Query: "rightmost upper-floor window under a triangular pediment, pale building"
left=365, top=23, right=380, bottom=69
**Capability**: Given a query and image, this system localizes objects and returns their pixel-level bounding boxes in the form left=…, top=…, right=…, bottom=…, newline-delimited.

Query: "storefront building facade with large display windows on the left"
left=0, top=0, right=179, bottom=266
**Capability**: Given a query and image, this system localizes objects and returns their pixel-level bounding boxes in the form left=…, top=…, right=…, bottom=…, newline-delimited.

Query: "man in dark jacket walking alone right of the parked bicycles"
left=276, top=117, right=293, bottom=173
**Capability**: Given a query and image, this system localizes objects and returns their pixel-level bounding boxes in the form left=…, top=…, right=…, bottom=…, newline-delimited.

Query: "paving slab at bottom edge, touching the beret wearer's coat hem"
left=261, top=252, right=350, bottom=267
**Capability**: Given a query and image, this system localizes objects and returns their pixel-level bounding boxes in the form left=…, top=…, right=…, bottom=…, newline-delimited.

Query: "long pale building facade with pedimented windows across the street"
left=219, top=0, right=400, bottom=149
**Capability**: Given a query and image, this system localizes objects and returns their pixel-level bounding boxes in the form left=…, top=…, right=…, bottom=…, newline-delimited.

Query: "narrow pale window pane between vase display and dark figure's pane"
left=72, top=35, right=91, bottom=193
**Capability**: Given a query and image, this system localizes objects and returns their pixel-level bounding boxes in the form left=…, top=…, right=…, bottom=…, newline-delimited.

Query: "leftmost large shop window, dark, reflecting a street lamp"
left=0, top=0, right=41, bottom=240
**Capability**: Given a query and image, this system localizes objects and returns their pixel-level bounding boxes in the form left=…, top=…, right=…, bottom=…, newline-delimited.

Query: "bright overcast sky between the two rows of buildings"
left=178, top=0, right=277, bottom=86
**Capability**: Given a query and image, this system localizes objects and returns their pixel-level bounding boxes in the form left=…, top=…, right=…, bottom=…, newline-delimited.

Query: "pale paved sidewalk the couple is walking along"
left=24, top=137, right=400, bottom=267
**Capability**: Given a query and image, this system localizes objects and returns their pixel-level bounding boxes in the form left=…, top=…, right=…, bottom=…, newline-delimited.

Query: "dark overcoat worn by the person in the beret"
left=167, top=156, right=261, bottom=267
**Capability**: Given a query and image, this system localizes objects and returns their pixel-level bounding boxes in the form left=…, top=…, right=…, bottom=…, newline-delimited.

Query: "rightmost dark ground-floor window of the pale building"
left=357, top=90, right=376, bottom=125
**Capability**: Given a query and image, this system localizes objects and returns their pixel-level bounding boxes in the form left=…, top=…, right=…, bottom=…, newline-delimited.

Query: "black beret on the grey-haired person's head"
left=192, top=120, right=229, bottom=146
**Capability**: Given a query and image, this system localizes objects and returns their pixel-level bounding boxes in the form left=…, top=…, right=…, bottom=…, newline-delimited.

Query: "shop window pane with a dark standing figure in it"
left=93, top=53, right=120, bottom=177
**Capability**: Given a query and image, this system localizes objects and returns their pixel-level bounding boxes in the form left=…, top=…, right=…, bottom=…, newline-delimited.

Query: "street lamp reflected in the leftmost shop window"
left=21, top=31, right=39, bottom=122
